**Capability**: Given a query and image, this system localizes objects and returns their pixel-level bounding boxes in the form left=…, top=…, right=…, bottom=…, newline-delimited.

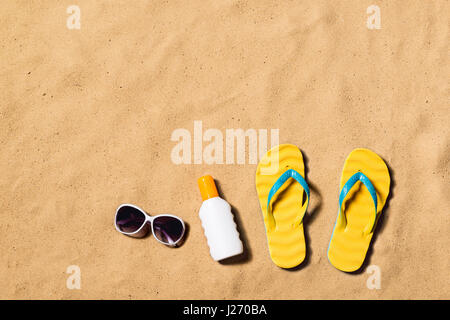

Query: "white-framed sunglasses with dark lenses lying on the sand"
left=114, top=204, right=186, bottom=247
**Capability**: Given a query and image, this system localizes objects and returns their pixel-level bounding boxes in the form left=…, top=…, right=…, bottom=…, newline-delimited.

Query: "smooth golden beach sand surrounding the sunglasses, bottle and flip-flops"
left=0, top=0, right=450, bottom=299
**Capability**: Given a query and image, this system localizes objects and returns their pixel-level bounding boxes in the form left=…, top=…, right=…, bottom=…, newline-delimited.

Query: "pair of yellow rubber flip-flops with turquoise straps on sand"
left=256, top=144, right=390, bottom=272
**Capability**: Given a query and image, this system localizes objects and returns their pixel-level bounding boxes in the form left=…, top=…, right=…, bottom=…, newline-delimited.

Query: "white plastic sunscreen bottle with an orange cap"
left=198, top=176, right=244, bottom=261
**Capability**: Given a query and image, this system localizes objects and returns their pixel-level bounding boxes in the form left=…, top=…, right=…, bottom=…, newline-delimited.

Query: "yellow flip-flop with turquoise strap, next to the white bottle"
left=256, top=144, right=309, bottom=268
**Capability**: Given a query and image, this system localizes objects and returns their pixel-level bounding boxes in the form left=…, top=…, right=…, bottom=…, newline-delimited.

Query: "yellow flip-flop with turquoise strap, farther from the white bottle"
left=328, top=149, right=391, bottom=272
